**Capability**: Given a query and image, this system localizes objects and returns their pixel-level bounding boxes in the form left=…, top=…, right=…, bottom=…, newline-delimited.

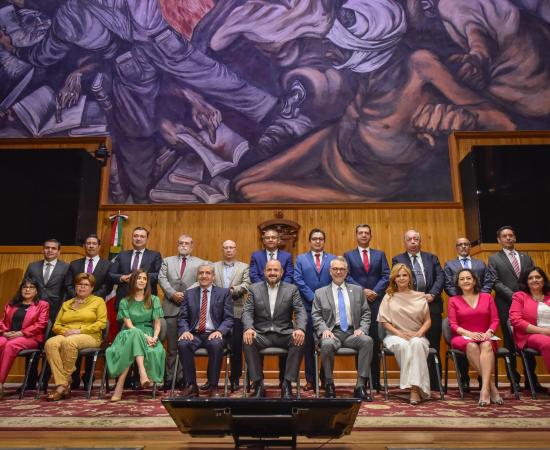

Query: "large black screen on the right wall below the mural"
left=459, top=145, right=550, bottom=244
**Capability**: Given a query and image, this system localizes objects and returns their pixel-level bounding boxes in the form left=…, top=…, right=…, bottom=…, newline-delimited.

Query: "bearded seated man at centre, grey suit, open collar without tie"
left=241, top=259, right=307, bottom=398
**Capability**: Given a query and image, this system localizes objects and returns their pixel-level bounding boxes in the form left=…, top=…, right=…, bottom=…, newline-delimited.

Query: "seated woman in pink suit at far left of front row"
left=0, top=279, right=50, bottom=398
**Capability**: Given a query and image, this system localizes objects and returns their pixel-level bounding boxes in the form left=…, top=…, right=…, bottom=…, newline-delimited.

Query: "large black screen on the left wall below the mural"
left=0, top=149, right=101, bottom=245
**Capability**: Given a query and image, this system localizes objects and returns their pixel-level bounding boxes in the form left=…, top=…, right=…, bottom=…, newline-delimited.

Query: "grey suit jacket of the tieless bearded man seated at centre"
left=242, top=281, right=307, bottom=334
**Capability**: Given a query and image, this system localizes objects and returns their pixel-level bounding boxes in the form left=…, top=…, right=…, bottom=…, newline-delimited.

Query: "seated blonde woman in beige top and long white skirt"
left=377, top=264, right=432, bottom=405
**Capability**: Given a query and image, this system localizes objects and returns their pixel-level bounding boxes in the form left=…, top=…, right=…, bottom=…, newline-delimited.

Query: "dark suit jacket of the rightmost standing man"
left=489, top=250, right=535, bottom=307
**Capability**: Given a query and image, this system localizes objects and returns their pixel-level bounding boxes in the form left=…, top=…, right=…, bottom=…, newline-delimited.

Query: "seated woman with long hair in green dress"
left=107, top=269, right=165, bottom=402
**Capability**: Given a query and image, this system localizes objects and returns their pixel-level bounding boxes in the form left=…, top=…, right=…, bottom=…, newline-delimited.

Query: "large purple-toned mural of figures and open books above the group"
left=0, top=0, right=550, bottom=203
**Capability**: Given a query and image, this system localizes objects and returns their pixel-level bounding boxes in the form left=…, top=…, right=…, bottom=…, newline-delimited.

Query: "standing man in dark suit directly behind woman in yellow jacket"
left=65, top=234, right=112, bottom=389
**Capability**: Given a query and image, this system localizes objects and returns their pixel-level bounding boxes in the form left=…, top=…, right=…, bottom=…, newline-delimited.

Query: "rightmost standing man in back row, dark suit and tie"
left=489, top=225, right=548, bottom=392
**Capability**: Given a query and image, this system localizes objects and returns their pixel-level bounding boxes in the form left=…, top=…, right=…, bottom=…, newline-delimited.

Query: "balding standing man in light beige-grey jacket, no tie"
left=214, top=240, right=250, bottom=392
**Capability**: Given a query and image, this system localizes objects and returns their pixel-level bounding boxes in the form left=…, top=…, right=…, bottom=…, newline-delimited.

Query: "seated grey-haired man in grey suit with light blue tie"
left=311, top=256, right=372, bottom=402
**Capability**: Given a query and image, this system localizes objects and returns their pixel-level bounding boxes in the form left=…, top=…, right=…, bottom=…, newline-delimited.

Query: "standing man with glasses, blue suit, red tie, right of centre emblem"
left=294, top=228, right=335, bottom=391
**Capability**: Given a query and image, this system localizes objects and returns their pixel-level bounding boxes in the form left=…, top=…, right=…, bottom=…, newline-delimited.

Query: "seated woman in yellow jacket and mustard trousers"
left=44, top=273, right=107, bottom=401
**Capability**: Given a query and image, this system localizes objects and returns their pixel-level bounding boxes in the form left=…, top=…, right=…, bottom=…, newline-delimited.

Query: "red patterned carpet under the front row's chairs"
left=0, top=388, right=550, bottom=431
